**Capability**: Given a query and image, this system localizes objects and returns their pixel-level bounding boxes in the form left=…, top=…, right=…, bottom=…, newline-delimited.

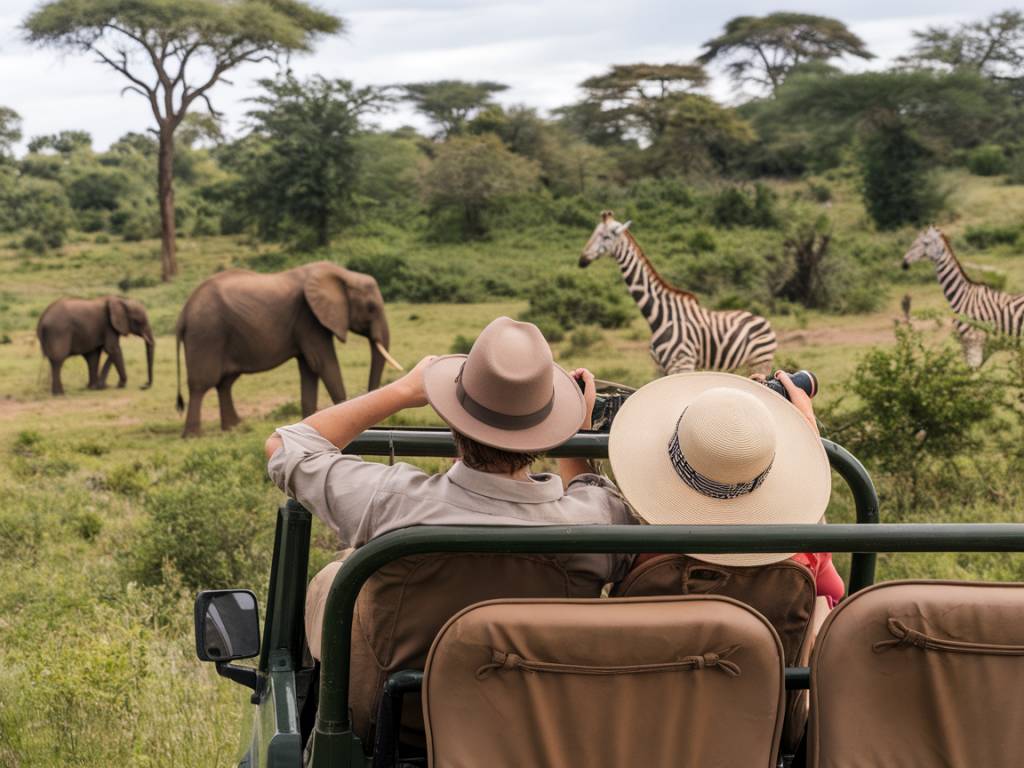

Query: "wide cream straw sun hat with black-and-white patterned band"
left=608, top=373, right=831, bottom=565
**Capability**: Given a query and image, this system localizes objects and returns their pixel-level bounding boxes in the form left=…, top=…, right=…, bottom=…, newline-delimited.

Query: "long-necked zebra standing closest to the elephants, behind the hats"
left=580, top=211, right=778, bottom=374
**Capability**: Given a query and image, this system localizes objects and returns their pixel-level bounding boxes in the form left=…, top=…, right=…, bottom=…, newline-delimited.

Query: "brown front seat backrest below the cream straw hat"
left=611, top=555, right=827, bottom=754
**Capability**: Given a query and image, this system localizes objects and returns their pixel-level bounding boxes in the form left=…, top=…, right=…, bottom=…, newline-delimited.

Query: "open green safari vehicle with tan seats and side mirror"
left=196, top=429, right=1024, bottom=768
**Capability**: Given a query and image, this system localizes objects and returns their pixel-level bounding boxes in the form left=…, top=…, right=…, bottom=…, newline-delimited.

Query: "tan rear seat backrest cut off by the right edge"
left=808, top=582, right=1024, bottom=768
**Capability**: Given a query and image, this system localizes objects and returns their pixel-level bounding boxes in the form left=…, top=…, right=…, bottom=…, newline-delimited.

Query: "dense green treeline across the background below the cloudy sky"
left=6, top=11, right=1024, bottom=306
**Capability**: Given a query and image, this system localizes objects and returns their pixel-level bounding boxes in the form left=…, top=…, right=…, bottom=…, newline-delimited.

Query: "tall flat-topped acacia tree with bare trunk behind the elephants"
left=24, top=0, right=342, bottom=281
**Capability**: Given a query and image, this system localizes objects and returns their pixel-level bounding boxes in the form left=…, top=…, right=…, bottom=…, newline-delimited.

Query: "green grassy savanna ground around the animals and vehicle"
left=0, top=172, right=1024, bottom=768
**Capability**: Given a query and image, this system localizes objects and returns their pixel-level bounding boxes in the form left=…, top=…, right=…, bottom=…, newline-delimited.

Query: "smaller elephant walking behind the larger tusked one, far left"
left=36, top=296, right=156, bottom=394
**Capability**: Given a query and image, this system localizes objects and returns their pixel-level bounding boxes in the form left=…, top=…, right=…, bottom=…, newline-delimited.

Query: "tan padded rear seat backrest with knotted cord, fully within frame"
left=423, top=596, right=783, bottom=768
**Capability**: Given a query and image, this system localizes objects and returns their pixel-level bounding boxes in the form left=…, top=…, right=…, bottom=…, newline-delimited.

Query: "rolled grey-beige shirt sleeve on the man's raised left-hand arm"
left=267, top=424, right=423, bottom=547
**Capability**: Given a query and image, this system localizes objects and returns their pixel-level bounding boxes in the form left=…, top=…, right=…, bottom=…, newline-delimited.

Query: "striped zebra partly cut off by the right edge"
left=903, top=226, right=1024, bottom=368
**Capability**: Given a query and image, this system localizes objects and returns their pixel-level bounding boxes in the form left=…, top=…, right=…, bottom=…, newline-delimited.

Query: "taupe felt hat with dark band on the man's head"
left=423, top=317, right=586, bottom=454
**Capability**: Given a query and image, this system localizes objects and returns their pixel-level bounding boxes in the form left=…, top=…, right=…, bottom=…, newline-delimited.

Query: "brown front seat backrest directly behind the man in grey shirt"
left=349, top=554, right=602, bottom=744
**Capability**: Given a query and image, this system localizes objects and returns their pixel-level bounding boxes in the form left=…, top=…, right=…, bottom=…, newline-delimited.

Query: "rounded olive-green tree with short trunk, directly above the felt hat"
left=422, top=134, right=539, bottom=238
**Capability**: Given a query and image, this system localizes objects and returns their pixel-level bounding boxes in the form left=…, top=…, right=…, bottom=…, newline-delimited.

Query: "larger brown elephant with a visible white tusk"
left=176, top=261, right=401, bottom=437
